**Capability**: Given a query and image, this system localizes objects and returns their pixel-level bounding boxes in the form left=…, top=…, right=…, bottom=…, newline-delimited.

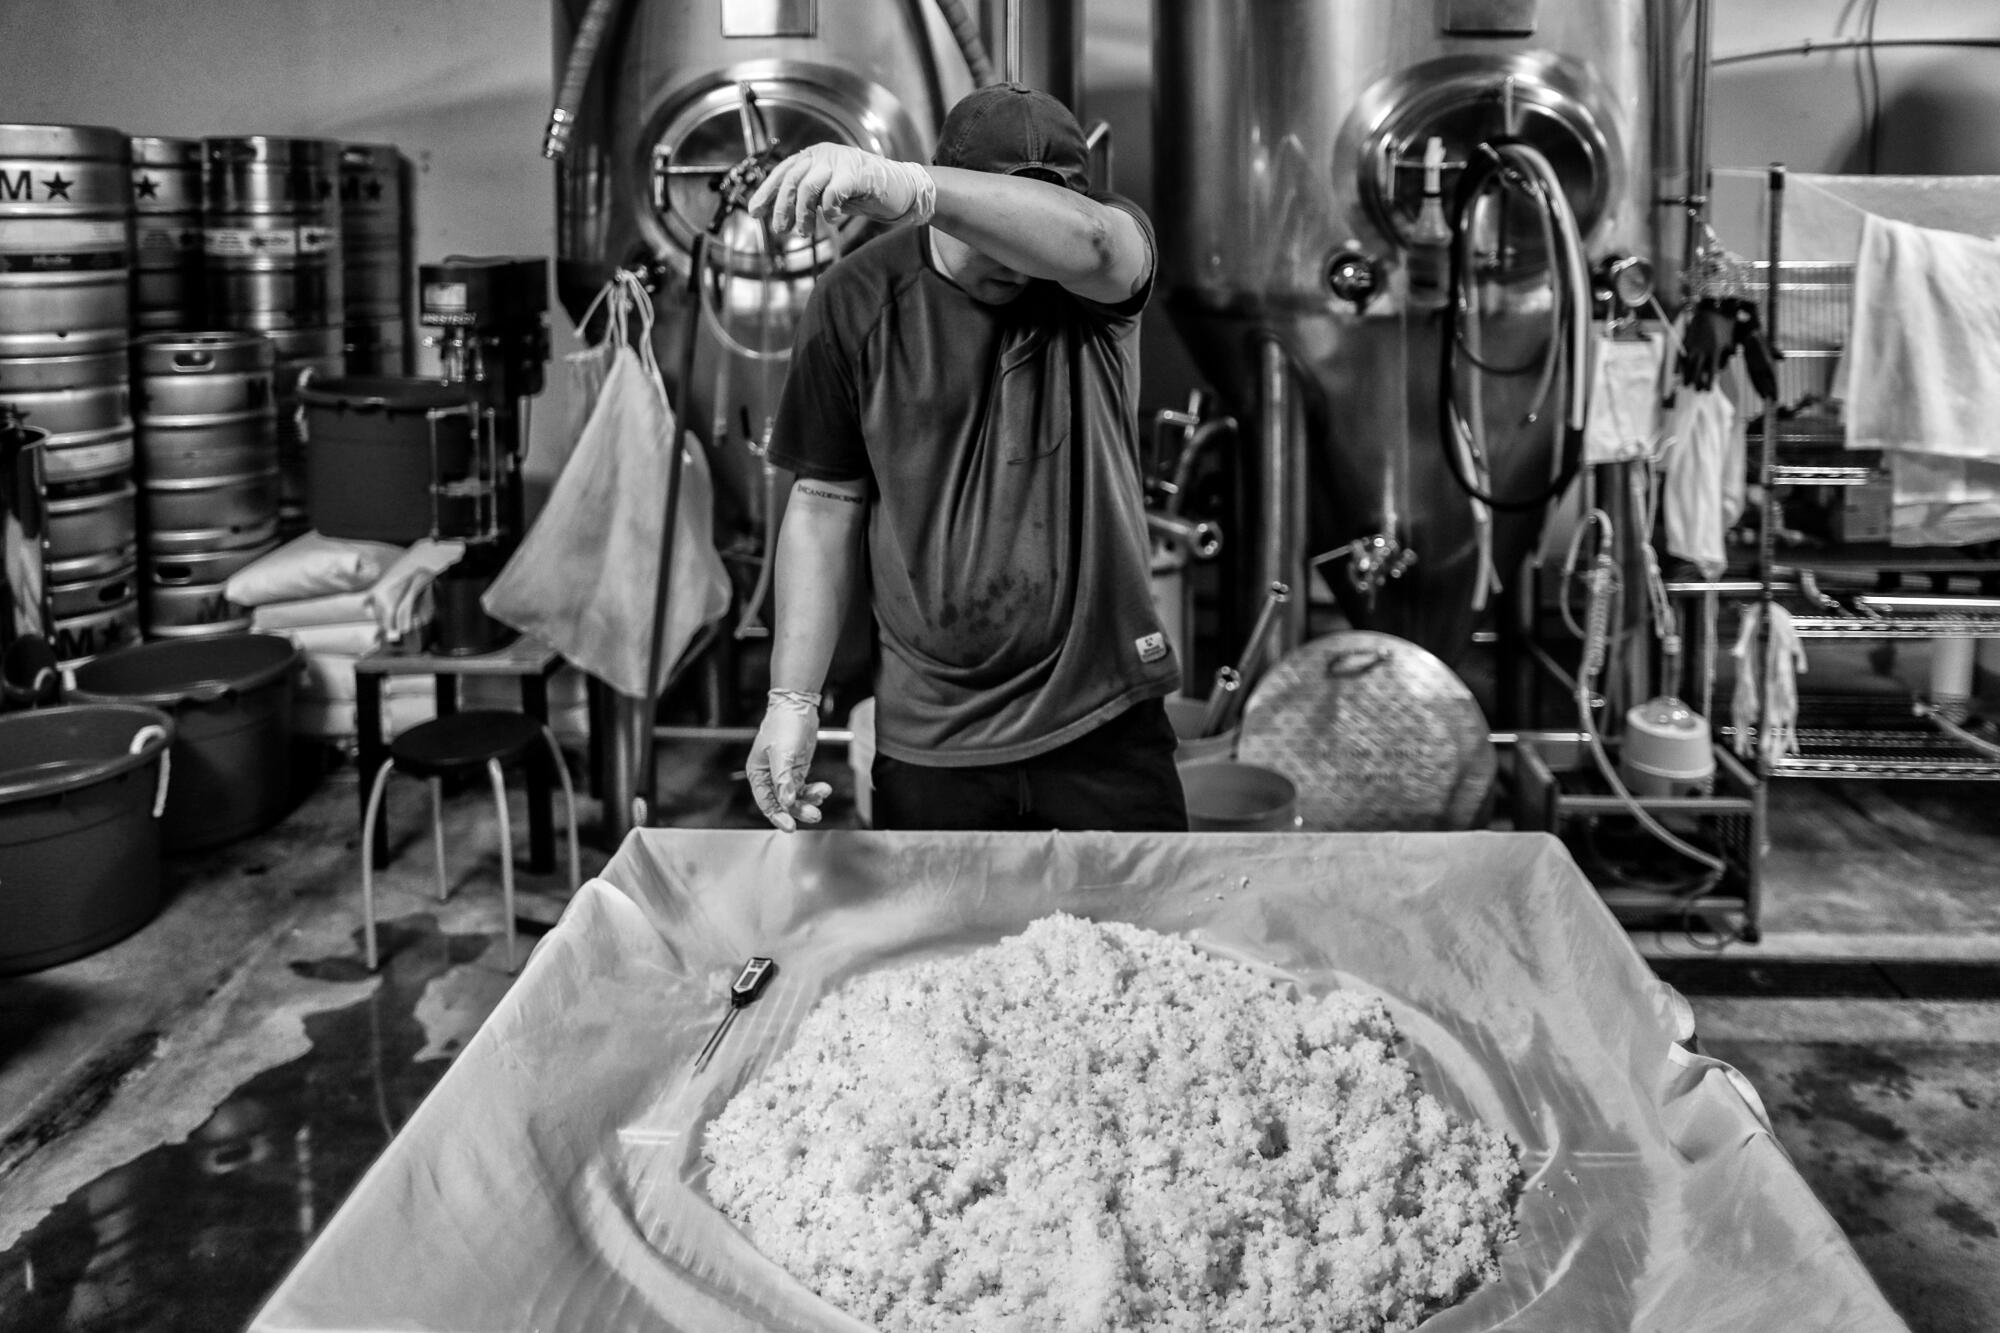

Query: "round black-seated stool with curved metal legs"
left=362, top=709, right=582, bottom=973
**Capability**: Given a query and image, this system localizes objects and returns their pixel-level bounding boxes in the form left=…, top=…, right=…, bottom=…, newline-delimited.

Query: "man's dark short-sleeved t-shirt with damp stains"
left=770, top=196, right=1180, bottom=767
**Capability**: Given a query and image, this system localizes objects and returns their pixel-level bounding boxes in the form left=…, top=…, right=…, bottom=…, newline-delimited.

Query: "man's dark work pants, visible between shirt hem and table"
left=872, top=699, right=1188, bottom=833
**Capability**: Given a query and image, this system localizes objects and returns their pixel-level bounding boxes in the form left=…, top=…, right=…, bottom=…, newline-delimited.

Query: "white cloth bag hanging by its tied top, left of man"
left=480, top=272, right=730, bottom=699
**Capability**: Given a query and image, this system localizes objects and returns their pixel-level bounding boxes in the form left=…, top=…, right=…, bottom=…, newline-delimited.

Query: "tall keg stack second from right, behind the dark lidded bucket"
left=202, top=136, right=346, bottom=536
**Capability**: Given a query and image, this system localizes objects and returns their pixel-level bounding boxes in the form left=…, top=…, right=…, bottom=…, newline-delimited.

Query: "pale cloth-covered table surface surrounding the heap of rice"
left=252, top=829, right=1908, bottom=1333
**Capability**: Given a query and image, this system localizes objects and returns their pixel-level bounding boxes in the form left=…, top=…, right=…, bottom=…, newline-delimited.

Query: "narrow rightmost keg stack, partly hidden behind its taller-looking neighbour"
left=340, top=144, right=412, bottom=374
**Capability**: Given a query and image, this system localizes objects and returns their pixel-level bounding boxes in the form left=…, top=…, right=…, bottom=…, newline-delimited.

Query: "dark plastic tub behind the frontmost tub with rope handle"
left=70, top=634, right=300, bottom=851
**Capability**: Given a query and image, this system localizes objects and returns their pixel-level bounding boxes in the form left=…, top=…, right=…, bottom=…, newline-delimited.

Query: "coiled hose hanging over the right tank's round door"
left=1438, top=138, right=1590, bottom=512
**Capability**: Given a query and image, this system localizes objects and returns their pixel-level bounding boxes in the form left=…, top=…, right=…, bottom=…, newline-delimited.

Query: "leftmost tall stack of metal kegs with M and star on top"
left=0, top=124, right=140, bottom=667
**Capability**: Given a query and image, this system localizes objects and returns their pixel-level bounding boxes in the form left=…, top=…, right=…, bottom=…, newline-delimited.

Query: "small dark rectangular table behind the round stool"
left=354, top=634, right=562, bottom=875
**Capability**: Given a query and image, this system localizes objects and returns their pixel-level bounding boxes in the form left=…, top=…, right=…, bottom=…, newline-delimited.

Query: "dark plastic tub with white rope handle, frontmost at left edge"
left=0, top=705, right=174, bottom=977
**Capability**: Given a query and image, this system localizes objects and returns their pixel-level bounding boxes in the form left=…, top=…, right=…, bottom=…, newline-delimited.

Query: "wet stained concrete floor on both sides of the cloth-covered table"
left=0, top=728, right=2000, bottom=1333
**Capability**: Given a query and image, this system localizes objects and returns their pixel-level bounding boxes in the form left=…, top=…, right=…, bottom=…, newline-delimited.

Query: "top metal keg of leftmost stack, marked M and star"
left=0, top=124, right=132, bottom=356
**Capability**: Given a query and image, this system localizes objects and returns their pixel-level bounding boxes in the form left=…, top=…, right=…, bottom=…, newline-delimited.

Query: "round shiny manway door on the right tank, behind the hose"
left=1352, top=56, right=1624, bottom=280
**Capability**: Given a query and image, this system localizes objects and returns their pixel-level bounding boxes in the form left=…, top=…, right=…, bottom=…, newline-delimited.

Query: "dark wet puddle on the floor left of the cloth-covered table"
left=0, top=915, right=496, bottom=1333
